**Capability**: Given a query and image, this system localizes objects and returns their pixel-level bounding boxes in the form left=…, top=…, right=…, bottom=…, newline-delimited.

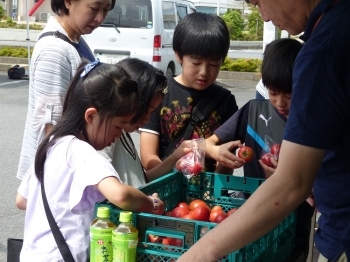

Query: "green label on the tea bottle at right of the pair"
left=112, top=232, right=138, bottom=262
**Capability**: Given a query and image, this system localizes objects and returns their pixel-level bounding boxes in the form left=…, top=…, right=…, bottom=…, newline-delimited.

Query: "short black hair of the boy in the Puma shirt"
left=261, top=38, right=303, bottom=94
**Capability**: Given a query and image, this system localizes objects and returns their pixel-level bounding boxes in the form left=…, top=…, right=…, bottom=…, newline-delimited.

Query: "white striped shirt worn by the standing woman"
left=17, top=17, right=93, bottom=179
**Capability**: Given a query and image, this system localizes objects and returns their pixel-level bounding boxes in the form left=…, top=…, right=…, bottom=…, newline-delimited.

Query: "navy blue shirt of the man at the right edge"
left=284, top=0, right=350, bottom=261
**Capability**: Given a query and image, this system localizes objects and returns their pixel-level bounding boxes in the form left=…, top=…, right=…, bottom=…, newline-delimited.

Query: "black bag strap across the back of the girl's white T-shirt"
left=41, top=179, right=75, bottom=262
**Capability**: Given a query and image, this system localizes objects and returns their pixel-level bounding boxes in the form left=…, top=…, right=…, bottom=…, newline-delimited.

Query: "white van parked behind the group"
left=84, top=0, right=196, bottom=75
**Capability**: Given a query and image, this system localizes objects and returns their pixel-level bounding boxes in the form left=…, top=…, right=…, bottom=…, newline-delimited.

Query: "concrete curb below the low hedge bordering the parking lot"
left=0, top=57, right=261, bottom=81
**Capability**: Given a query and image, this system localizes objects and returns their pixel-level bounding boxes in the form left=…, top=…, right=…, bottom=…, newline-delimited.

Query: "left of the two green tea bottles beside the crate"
left=90, top=207, right=115, bottom=262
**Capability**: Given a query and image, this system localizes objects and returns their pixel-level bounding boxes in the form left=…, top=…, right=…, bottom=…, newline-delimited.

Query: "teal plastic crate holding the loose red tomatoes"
left=95, top=172, right=296, bottom=262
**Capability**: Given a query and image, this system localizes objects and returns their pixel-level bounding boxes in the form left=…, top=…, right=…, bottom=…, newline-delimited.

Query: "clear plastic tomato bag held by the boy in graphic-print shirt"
left=175, top=138, right=205, bottom=179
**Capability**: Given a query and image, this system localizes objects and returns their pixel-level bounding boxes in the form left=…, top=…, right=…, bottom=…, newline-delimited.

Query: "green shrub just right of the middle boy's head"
left=221, top=9, right=244, bottom=40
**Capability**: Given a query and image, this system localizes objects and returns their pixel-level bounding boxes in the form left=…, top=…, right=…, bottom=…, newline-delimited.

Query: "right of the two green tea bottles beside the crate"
left=112, top=211, right=138, bottom=262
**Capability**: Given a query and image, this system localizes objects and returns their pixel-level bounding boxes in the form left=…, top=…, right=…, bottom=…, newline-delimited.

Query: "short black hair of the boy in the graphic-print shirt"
left=173, top=13, right=230, bottom=62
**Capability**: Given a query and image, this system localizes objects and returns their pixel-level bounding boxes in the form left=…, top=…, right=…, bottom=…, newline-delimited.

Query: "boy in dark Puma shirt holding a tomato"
left=206, top=38, right=314, bottom=260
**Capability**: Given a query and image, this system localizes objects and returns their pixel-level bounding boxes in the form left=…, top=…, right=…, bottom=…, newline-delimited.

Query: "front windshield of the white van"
left=101, top=0, right=153, bottom=28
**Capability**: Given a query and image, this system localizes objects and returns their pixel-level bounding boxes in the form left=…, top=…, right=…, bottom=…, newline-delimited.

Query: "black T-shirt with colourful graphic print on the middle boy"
left=142, top=77, right=238, bottom=172
